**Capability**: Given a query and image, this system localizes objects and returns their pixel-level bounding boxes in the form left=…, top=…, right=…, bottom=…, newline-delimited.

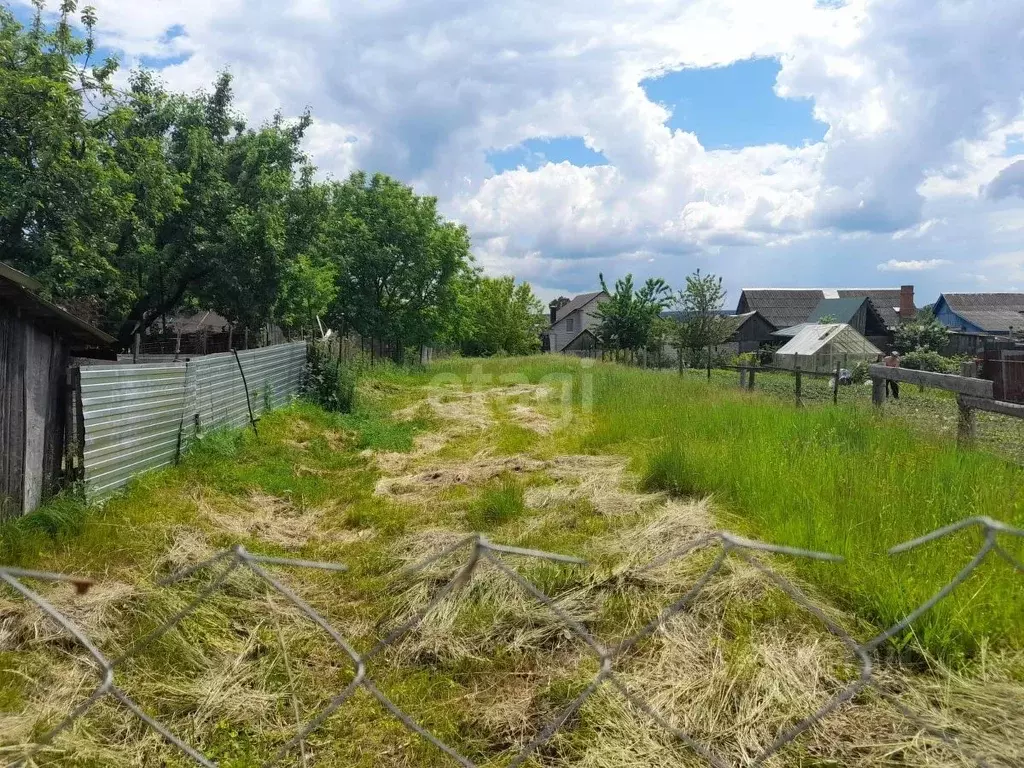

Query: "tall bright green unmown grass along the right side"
left=433, top=357, right=1024, bottom=659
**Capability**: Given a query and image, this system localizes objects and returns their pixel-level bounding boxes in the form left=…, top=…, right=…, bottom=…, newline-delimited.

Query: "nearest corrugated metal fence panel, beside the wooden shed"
left=81, top=364, right=185, bottom=501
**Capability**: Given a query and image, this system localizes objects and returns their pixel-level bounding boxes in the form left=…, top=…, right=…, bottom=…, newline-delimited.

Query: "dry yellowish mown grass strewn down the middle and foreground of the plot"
left=0, top=387, right=1024, bottom=768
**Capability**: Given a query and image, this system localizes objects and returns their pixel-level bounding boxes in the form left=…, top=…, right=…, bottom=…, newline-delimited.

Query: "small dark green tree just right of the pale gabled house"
left=594, top=274, right=671, bottom=352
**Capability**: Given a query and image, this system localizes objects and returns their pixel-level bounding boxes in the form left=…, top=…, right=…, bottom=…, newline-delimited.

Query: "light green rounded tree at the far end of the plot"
left=462, top=276, right=546, bottom=355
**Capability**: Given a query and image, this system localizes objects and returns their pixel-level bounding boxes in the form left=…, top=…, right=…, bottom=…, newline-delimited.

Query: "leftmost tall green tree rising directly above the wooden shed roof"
left=0, top=2, right=132, bottom=323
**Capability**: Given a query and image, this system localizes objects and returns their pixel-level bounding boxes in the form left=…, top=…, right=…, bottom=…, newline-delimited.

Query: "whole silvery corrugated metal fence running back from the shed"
left=80, top=342, right=306, bottom=502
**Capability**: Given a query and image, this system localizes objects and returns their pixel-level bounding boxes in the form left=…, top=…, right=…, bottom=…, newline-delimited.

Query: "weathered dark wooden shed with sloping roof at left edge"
left=0, top=263, right=115, bottom=518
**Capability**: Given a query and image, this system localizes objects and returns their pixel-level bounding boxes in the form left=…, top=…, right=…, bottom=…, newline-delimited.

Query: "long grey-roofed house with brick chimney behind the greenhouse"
left=736, top=286, right=918, bottom=333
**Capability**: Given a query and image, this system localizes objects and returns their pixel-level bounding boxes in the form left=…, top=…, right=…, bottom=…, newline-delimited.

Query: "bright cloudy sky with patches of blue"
left=7, top=0, right=1024, bottom=313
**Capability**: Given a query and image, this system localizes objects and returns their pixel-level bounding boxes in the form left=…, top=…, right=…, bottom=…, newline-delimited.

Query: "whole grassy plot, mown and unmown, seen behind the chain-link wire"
left=0, top=357, right=1024, bottom=768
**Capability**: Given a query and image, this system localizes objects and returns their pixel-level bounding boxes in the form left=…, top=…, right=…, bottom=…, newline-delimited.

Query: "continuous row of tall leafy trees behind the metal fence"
left=0, top=0, right=472, bottom=353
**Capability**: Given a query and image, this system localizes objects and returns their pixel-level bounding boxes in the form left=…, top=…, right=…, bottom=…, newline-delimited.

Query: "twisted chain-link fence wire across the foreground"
left=0, top=517, right=1024, bottom=768
